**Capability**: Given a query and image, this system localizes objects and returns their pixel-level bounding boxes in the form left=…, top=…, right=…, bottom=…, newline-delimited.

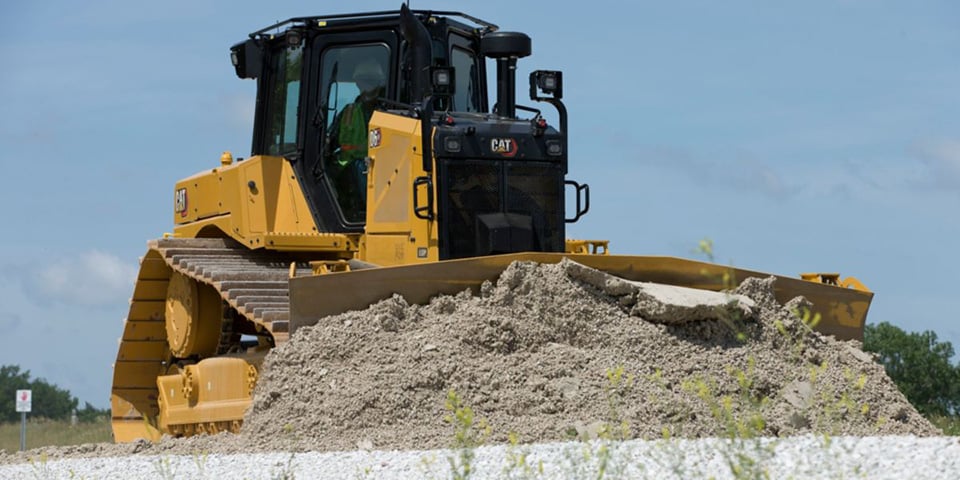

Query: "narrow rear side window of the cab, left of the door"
left=266, top=46, right=303, bottom=156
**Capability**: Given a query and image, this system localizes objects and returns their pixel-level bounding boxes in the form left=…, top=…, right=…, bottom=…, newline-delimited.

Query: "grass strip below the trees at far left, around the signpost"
left=0, top=417, right=113, bottom=452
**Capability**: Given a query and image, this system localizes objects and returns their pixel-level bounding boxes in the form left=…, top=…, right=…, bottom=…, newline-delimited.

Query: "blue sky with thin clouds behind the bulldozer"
left=0, top=0, right=960, bottom=407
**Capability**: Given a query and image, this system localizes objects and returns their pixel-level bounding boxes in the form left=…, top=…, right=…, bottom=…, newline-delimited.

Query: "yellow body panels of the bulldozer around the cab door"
left=173, top=112, right=438, bottom=265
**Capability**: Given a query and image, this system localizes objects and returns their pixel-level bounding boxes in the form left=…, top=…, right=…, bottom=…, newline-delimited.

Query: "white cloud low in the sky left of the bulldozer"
left=23, top=250, right=137, bottom=306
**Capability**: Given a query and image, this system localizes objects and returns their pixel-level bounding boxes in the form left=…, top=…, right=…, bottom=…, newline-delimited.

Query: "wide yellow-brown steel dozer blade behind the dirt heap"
left=290, top=253, right=873, bottom=340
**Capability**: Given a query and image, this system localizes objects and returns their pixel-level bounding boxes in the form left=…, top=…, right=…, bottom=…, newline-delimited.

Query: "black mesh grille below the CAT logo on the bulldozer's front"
left=438, top=160, right=564, bottom=258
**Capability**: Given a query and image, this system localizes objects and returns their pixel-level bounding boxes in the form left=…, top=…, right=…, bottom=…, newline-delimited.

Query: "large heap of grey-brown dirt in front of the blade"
left=242, top=261, right=939, bottom=450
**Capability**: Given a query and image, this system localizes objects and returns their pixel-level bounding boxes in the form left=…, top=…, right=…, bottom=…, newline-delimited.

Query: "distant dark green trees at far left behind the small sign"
left=0, top=365, right=108, bottom=422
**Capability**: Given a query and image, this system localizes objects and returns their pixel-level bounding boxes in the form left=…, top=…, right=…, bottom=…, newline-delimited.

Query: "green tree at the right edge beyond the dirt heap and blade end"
left=863, top=322, right=960, bottom=415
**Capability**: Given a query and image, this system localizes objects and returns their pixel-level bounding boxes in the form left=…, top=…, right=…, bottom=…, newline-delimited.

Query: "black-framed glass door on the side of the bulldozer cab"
left=295, top=30, right=399, bottom=233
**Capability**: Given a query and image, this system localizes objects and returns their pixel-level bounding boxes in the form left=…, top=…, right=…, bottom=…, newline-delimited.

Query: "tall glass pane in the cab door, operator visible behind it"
left=320, top=43, right=390, bottom=223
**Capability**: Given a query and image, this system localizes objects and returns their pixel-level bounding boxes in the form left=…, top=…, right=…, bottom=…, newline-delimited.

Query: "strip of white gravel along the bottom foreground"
left=0, top=435, right=960, bottom=480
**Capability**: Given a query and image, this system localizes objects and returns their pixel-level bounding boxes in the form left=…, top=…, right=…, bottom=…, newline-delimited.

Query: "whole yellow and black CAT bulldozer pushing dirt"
left=111, top=6, right=872, bottom=442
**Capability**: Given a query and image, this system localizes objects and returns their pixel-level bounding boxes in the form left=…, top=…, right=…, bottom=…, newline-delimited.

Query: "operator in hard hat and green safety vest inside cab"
left=328, top=59, right=387, bottom=222
